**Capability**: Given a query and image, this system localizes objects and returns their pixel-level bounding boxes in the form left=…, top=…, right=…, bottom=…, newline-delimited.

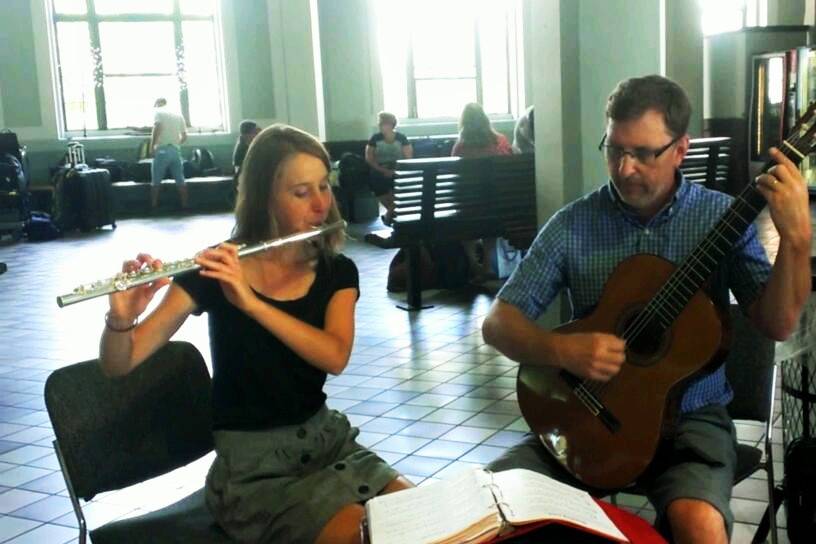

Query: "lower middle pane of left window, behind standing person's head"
left=105, top=75, right=181, bottom=128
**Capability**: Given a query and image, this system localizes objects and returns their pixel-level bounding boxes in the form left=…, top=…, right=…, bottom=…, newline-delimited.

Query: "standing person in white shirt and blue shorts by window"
left=150, top=98, right=188, bottom=213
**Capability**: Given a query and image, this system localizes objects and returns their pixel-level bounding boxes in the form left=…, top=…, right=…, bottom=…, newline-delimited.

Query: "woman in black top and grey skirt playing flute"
left=100, top=125, right=411, bottom=544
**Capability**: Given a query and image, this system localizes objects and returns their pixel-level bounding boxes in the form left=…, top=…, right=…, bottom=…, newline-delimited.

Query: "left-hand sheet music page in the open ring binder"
left=366, top=469, right=501, bottom=544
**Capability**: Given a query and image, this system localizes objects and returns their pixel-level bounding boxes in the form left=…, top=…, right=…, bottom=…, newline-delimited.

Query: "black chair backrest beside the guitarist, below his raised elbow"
left=725, top=304, right=776, bottom=422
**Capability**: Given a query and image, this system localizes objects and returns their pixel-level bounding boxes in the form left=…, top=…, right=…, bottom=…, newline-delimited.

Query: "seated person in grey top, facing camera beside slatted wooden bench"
left=366, top=111, right=414, bottom=225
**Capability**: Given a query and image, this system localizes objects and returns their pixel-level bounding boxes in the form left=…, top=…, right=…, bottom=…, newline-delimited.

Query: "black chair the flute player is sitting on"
left=45, top=342, right=230, bottom=544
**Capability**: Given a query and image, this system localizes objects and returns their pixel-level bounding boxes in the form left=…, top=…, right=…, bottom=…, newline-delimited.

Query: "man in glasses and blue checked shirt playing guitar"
left=482, top=76, right=811, bottom=544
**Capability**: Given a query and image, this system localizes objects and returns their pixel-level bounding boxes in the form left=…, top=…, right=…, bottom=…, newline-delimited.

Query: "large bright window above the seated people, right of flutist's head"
left=373, top=0, right=522, bottom=119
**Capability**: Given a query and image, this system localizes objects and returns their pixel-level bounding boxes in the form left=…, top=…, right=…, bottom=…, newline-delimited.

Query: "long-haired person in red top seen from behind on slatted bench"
left=451, top=102, right=512, bottom=283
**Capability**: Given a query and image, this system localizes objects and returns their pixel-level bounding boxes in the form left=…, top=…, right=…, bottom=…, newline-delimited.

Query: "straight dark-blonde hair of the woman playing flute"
left=232, top=124, right=345, bottom=252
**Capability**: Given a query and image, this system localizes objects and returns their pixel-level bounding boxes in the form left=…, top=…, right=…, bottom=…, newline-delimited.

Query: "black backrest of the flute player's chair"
left=45, top=342, right=213, bottom=500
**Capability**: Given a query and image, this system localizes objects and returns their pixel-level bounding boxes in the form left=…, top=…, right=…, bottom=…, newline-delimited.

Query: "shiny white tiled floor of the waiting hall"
left=0, top=214, right=787, bottom=544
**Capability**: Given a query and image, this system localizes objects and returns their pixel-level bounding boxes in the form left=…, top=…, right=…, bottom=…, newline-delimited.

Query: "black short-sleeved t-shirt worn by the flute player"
left=175, top=255, right=359, bottom=430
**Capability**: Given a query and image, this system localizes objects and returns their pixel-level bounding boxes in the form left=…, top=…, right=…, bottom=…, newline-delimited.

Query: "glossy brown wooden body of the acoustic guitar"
left=517, top=255, right=726, bottom=489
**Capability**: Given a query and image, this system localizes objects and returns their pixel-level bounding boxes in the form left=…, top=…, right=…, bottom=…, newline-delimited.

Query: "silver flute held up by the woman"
left=57, top=220, right=346, bottom=308
